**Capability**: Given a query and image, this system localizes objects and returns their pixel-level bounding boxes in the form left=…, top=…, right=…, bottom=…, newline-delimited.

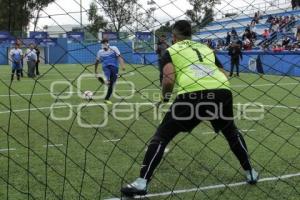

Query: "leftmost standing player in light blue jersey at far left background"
left=9, top=42, right=23, bottom=81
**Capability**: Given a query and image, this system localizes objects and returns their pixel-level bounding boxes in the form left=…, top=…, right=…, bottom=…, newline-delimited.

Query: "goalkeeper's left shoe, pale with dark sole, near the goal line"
left=121, top=178, right=147, bottom=197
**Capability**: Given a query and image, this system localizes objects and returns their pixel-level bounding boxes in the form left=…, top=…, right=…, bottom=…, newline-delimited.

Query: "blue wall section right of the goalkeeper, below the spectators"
left=217, top=51, right=300, bottom=76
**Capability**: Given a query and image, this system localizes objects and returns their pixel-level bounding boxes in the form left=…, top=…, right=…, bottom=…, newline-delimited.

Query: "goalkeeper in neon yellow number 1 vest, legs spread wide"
left=121, top=20, right=258, bottom=197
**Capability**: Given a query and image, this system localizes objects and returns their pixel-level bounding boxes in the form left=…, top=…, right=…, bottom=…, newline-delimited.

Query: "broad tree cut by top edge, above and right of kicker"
left=97, top=0, right=137, bottom=32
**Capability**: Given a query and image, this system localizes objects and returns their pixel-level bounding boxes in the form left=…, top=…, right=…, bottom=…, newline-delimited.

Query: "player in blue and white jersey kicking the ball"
left=95, top=39, right=125, bottom=104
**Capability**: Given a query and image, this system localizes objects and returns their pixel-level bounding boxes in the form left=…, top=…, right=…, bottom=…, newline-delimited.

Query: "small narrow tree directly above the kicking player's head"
left=87, top=2, right=107, bottom=38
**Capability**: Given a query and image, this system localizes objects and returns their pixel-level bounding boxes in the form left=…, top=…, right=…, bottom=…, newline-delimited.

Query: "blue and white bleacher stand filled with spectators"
left=194, top=8, right=300, bottom=50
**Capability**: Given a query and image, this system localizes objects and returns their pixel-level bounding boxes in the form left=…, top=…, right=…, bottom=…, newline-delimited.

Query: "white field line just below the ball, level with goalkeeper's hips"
left=0, top=103, right=300, bottom=114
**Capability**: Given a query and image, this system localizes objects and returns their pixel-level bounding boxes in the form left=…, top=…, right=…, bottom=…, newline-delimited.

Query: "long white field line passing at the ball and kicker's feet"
left=0, top=81, right=300, bottom=97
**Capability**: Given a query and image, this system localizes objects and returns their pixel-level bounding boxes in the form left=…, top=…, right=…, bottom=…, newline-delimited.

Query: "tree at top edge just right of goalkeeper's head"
left=186, top=0, right=220, bottom=28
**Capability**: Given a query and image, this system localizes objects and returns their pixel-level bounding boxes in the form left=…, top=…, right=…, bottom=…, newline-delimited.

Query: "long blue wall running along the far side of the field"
left=0, top=38, right=300, bottom=76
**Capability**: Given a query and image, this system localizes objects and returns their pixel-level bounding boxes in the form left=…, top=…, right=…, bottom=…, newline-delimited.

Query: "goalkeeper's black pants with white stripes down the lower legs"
left=140, top=89, right=252, bottom=181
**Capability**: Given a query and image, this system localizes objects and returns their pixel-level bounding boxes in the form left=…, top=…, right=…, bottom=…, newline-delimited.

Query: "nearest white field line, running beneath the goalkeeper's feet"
left=105, top=173, right=300, bottom=200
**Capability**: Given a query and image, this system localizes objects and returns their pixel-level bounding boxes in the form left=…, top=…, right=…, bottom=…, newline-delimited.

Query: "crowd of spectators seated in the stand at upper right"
left=205, top=12, right=300, bottom=52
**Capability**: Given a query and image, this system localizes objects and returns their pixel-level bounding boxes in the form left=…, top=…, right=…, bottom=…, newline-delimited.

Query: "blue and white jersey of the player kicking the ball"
left=97, top=46, right=120, bottom=68
